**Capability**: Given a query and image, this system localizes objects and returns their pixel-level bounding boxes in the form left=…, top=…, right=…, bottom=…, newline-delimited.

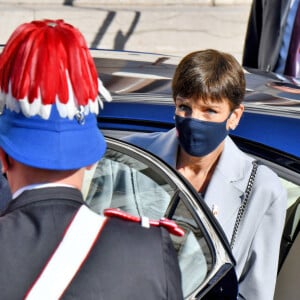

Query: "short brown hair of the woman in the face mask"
left=172, top=49, right=246, bottom=109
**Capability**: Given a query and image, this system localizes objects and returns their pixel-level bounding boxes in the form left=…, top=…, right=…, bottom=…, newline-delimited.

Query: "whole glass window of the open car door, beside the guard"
left=83, top=149, right=212, bottom=296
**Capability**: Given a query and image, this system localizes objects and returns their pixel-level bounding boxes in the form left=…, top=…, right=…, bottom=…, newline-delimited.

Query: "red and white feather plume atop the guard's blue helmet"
left=0, top=20, right=111, bottom=119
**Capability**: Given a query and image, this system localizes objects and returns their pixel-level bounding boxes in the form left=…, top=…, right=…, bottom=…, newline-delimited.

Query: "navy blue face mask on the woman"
left=175, top=114, right=231, bottom=156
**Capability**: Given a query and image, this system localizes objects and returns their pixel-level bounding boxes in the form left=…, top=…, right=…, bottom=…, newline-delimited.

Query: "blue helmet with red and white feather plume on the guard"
left=0, top=20, right=111, bottom=170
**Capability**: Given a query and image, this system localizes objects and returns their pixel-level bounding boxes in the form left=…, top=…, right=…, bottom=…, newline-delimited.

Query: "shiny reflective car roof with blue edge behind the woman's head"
left=91, top=49, right=300, bottom=157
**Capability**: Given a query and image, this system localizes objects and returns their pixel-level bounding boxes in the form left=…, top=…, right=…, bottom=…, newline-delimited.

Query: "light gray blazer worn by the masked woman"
left=124, top=129, right=287, bottom=300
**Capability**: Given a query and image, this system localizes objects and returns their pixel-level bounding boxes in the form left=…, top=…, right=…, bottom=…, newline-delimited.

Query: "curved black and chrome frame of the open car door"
left=90, top=135, right=238, bottom=299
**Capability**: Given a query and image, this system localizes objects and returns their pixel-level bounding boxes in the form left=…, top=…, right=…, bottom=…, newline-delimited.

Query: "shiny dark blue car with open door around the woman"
left=84, top=50, right=300, bottom=299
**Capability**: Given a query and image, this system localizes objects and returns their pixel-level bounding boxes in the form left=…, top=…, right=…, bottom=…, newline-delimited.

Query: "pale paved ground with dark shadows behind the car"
left=0, top=1, right=250, bottom=60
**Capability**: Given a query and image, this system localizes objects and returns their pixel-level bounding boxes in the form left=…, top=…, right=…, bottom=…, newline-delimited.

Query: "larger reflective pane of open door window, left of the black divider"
left=86, top=149, right=174, bottom=219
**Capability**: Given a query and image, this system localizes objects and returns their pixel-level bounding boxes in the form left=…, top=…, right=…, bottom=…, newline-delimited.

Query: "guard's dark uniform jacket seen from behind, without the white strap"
left=0, top=187, right=182, bottom=300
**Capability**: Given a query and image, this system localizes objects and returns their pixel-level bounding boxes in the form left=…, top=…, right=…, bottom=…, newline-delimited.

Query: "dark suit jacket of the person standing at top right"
left=242, top=0, right=291, bottom=72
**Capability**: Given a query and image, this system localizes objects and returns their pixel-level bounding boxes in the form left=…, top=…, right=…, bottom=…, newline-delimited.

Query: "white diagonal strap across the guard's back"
left=24, top=205, right=107, bottom=300
